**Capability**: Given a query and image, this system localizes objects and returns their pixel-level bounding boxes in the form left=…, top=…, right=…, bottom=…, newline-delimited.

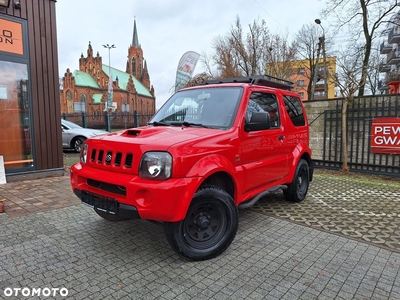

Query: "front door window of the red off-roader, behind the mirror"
left=246, top=92, right=280, bottom=128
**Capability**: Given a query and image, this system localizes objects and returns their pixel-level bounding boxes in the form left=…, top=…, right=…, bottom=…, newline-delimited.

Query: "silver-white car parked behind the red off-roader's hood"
left=61, top=119, right=108, bottom=152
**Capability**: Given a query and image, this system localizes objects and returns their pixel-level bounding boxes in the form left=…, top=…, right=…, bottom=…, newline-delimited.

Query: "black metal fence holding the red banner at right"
left=311, top=95, right=400, bottom=177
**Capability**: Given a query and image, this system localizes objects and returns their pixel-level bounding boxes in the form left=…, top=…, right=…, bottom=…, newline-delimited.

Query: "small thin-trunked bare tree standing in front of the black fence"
left=335, top=50, right=365, bottom=172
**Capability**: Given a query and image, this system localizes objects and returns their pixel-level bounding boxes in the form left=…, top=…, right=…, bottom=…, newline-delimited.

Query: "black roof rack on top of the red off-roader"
left=203, top=74, right=294, bottom=91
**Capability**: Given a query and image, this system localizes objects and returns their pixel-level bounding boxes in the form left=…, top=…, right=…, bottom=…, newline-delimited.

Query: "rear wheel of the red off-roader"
left=283, top=159, right=310, bottom=202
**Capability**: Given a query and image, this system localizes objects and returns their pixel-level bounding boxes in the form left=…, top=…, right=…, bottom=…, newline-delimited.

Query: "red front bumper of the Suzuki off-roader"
left=70, top=163, right=202, bottom=222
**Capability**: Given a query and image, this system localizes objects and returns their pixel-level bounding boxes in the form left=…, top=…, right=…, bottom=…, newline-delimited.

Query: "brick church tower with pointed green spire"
left=126, top=20, right=150, bottom=90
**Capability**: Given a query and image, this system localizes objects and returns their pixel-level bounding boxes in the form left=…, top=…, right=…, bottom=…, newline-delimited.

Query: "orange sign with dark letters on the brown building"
left=0, top=18, right=24, bottom=55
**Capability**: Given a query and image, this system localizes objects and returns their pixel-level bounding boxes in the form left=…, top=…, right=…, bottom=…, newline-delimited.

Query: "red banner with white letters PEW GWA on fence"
left=371, top=117, right=400, bottom=154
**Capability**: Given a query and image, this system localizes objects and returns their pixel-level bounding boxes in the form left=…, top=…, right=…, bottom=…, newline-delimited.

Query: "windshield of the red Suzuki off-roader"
left=149, top=87, right=243, bottom=129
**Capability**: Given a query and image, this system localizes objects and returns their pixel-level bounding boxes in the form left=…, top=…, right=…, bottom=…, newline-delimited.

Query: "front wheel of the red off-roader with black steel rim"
left=164, top=186, right=239, bottom=261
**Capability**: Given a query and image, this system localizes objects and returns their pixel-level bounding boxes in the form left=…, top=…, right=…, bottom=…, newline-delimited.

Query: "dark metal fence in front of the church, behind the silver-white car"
left=62, top=111, right=153, bottom=131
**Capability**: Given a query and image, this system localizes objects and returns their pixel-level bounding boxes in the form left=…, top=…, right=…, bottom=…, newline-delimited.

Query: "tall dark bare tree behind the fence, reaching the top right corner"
left=324, top=0, right=399, bottom=96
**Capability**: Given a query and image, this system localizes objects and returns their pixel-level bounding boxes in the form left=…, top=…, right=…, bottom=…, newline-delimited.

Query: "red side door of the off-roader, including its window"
left=240, top=91, right=289, bottom=192
